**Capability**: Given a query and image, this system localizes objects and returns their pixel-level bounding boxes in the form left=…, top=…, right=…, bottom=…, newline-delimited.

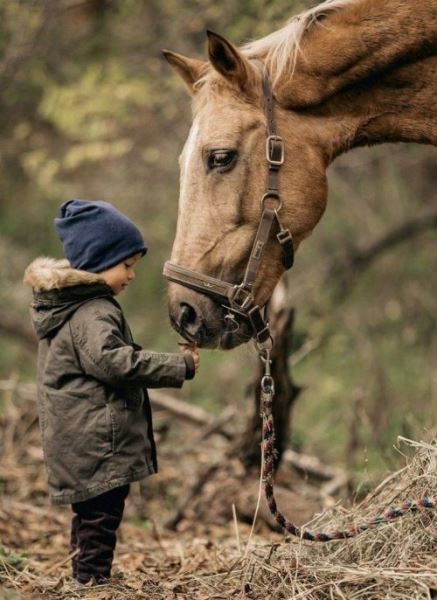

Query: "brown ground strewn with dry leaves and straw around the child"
left=0, top=390, right=437, bottom=600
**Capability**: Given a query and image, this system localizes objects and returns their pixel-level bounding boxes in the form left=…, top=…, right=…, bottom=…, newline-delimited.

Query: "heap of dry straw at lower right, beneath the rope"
left=237, top=436, right=437, bottom=600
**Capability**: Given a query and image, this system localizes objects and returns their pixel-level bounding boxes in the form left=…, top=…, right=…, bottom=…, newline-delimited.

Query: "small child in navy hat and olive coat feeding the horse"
left=24, top=200, right=199, bottom=583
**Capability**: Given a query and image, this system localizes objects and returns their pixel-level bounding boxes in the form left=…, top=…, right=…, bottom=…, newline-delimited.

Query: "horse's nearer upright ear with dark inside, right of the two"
left=206, top=31, right=255, bottom=91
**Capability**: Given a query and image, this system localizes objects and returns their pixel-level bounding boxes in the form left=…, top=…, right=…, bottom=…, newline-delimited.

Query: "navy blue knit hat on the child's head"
left=55, top=200, right=147, bottom=273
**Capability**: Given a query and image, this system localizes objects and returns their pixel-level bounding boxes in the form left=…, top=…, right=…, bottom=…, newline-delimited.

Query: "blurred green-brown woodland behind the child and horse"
left=0, top=0, right=437, bottom=479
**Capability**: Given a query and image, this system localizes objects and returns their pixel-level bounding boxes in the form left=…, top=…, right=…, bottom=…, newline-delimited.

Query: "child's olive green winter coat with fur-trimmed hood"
left=25, top=258, right=190, bottom=504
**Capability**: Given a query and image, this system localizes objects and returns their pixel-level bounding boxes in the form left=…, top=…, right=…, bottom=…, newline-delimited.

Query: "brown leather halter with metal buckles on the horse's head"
left=163, top=61, right=294, bottom=345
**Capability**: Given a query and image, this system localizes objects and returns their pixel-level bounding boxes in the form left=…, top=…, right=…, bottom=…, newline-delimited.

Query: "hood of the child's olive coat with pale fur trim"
left=24, top=256, right=115, bottom=339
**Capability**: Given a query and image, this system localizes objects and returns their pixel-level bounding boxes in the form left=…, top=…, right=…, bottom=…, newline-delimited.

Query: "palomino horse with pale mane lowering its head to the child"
left=164, top=0, right=437, bottom=348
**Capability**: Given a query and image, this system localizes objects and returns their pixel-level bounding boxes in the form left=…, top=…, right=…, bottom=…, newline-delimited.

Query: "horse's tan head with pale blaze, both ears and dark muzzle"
left=165, top=33, right=326, bottom=348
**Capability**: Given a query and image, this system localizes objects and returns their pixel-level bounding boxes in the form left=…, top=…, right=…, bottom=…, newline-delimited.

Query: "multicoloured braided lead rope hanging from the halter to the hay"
left=258, top=348, right=437, bottom=542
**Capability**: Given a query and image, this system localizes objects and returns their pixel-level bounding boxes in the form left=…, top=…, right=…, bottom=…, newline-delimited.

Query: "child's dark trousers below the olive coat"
left=71, top=485, right=129, bottom=583
